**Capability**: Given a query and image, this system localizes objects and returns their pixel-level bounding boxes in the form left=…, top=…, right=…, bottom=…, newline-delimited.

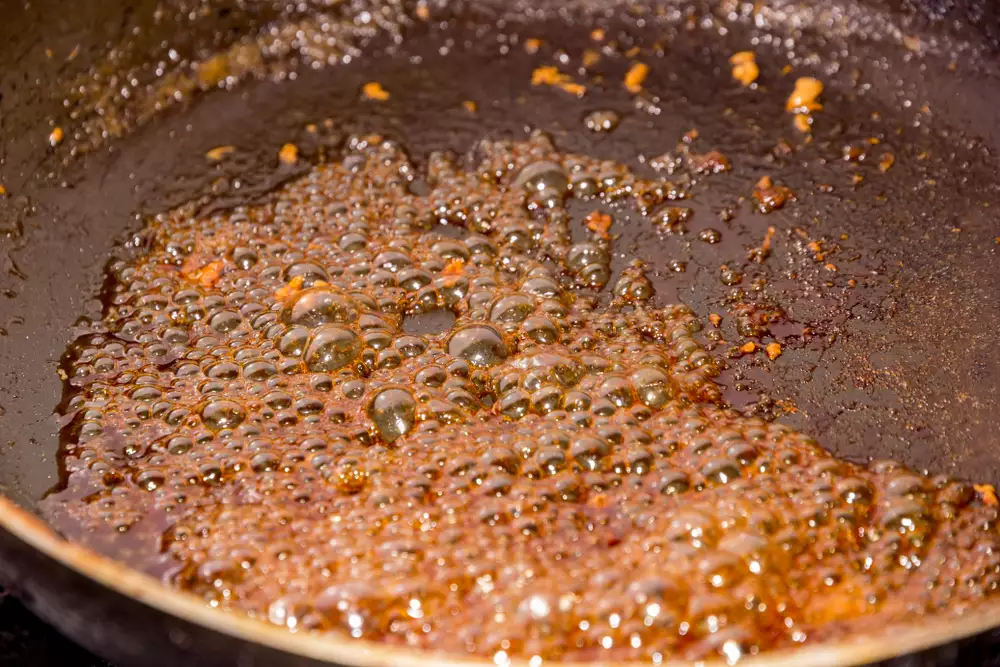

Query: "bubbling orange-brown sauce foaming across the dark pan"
left=47, top=134, right=1000, bottom=662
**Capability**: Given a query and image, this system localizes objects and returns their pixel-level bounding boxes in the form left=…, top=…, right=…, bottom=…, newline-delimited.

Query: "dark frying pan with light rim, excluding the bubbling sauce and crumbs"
left=0, top=0, right=1000, bottom=667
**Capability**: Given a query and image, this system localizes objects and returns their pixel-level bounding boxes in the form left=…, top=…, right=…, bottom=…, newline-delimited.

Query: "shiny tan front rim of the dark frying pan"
left=0, top=494, right=1000, bottom=667
